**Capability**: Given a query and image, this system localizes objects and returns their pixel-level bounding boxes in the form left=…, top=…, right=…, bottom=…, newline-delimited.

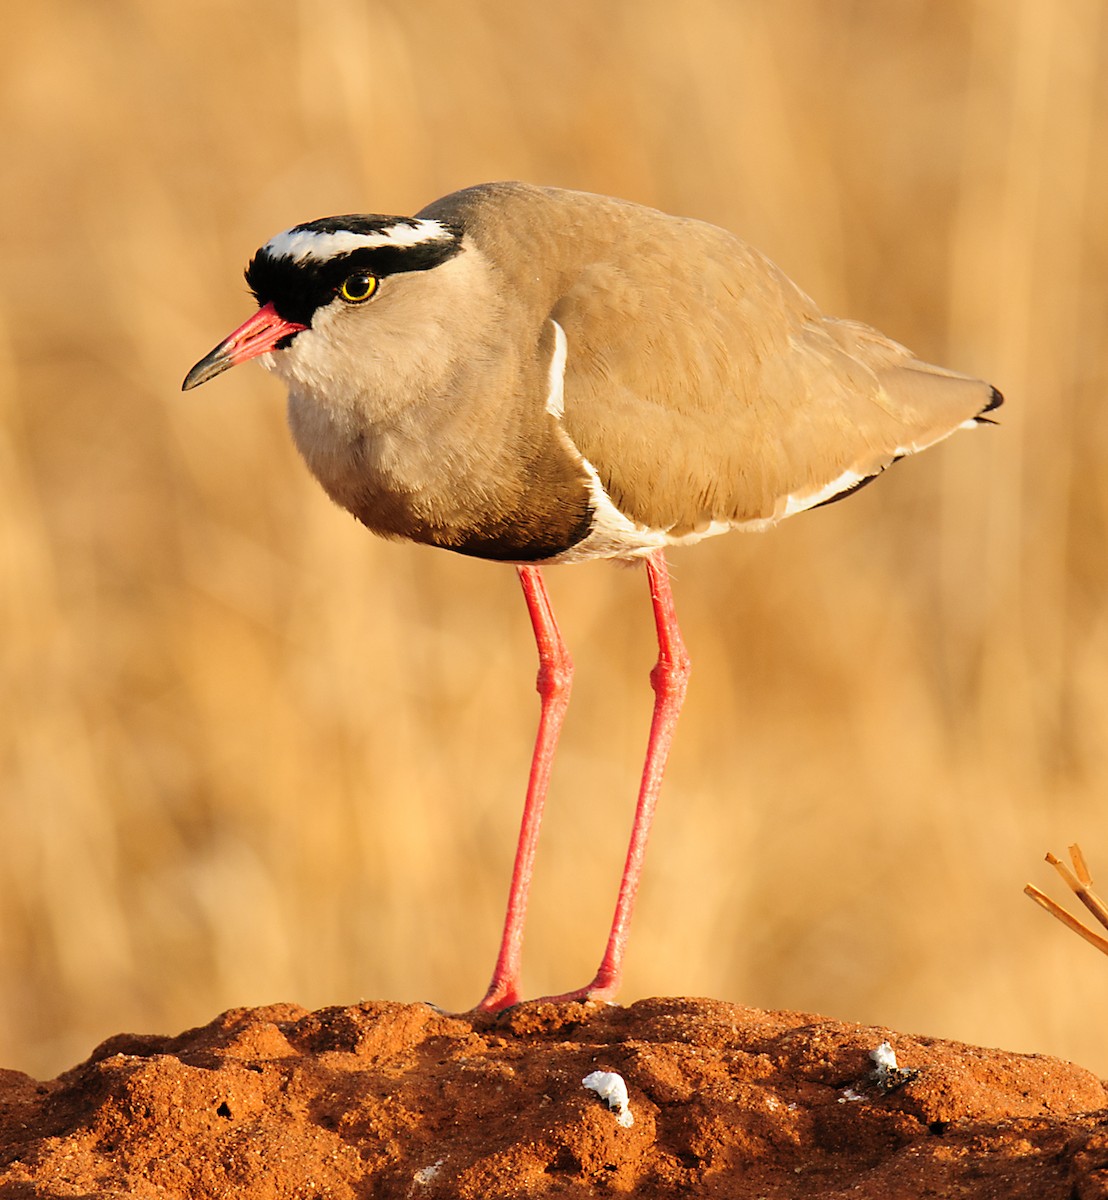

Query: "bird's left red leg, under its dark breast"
left=477, top=566, right=574, bottom=1013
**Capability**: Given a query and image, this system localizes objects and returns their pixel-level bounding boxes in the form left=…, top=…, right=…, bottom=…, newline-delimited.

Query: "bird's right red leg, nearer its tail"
left=549, top=550, right=690, bottom=1000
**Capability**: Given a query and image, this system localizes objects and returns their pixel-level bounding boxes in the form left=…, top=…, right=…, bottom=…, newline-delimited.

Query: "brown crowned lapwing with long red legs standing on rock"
left=182, top=182, right=1002, bottom=1013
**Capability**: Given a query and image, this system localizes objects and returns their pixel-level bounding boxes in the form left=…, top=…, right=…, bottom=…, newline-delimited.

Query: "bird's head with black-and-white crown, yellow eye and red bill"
left=181, top=216, right=462, bottom=391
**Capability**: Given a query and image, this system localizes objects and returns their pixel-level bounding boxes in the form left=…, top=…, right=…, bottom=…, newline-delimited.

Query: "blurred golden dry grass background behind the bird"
left=0, top=0, right=1108, bottom=1074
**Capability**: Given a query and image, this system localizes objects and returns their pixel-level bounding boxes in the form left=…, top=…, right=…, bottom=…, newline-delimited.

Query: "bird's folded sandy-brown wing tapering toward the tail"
left=552, top=211, right=995, bottom=534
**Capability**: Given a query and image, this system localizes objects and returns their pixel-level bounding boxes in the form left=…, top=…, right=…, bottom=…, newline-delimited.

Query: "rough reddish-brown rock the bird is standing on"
left=0, top=1000, right=1108, bottom=1200
